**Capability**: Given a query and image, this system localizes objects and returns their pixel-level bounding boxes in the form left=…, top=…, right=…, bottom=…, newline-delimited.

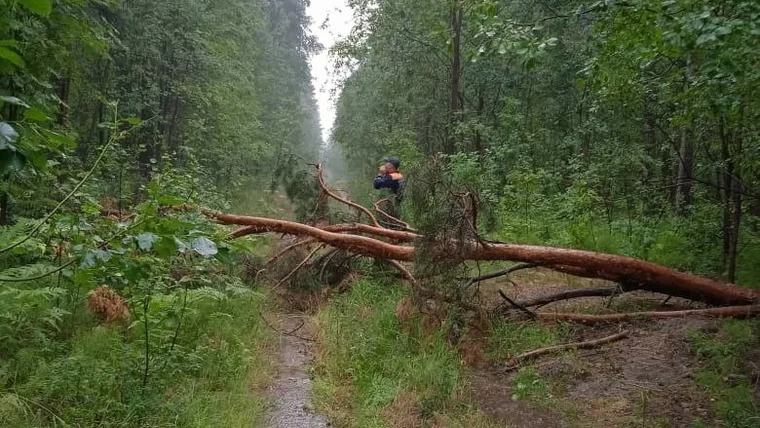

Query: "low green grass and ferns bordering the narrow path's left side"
left=0, top=291, right=272, bottom=428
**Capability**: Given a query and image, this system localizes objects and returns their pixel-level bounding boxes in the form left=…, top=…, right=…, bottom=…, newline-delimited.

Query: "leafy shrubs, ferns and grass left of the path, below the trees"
left=0, top=171, right=272, bottom=428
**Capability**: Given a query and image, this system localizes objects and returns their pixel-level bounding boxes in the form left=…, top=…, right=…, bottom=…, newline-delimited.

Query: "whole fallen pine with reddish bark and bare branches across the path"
left=151, top=165, right=760, bottom=322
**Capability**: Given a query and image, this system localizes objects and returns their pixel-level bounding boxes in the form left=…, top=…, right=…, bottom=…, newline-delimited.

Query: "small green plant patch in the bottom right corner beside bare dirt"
left=689, top=320, right=760, bottom=428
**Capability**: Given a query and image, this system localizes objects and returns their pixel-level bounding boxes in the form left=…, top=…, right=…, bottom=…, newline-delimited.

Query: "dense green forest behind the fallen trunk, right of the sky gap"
left=333, top=0, right=760, bottom=284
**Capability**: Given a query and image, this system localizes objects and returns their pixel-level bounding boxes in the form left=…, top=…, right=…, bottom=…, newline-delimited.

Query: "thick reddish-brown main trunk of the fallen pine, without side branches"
left=204, top=210, right=760, bottom=306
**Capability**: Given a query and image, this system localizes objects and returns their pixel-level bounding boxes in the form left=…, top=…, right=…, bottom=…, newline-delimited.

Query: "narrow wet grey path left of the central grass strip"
left=265, top=314, right=331, bottom=428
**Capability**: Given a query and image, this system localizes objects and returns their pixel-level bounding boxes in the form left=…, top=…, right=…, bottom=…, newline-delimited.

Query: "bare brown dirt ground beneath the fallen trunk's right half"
left=469, top=270, right=717, bottom=428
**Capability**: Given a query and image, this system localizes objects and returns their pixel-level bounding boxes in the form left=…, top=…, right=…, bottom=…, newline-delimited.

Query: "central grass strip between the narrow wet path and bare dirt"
left=314, top=279, right=498, bottom=427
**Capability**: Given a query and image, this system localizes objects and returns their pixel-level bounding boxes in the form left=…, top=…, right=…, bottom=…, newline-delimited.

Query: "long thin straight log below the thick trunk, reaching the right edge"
left=537, top=305, right=760, bottom=324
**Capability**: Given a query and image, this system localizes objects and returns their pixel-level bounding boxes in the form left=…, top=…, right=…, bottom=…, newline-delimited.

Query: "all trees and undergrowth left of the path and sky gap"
left=0, top=0, right=322, bottom=427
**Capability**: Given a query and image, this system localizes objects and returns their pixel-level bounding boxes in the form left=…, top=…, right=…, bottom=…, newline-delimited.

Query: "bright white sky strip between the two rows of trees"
left=306, top=0, right=353, bottom=141
